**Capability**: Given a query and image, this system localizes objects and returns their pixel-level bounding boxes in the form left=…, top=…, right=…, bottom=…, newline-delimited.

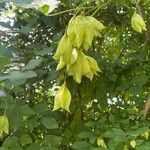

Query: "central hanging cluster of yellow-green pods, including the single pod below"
left=53, top=15, right=105, bottom=112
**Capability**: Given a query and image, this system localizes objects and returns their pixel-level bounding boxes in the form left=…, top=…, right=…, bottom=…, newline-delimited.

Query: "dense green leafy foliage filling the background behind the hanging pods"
left=0, top=0, right=150, bottom=150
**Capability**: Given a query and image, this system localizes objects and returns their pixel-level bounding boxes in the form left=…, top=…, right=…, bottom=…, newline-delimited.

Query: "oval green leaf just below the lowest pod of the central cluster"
left=41, top=117, right=58, bottom=129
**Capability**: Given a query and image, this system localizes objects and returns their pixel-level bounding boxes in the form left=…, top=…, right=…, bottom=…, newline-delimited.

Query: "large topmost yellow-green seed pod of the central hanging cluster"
left=67, top=15, right=105, bottom=50
